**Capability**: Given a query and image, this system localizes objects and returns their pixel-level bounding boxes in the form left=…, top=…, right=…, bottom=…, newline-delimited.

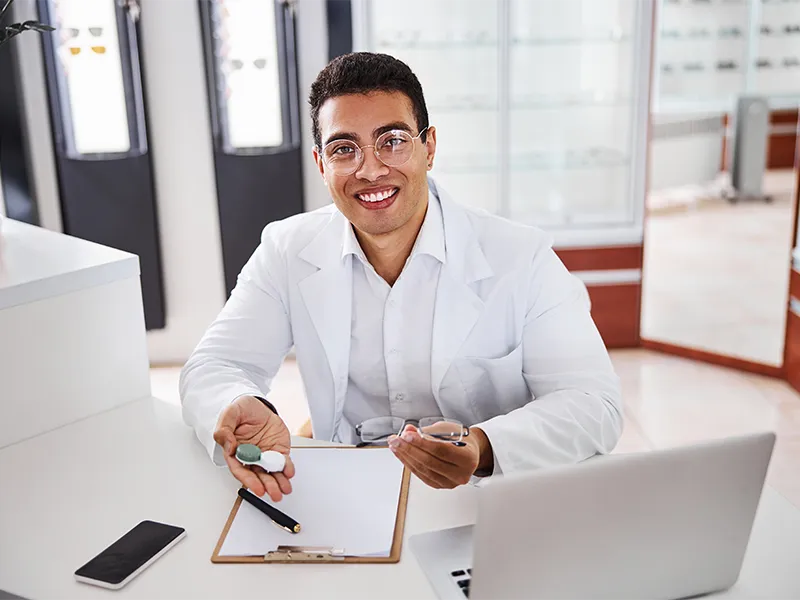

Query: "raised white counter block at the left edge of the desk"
left=0, top=219, right=150, bottom=448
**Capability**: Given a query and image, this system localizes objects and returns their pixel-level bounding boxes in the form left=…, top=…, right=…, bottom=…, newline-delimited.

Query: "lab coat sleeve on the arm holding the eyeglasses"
left=475, top=248, right=623, bottom=474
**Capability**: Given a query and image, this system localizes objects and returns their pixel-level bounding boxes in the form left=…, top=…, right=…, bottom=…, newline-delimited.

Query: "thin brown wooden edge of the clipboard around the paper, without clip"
left=211, top=446, right=411, bottom=565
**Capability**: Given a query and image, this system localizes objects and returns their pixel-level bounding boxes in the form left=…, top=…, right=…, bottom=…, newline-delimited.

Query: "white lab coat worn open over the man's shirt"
left=180, top=180, right=622, bottom=473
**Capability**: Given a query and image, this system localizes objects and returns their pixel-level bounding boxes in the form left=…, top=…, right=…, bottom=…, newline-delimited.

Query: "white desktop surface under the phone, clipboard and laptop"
left=0, top=399, right=800, bottom=600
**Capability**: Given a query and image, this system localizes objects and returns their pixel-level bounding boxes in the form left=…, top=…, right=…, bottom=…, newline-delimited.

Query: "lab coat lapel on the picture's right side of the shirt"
left=429, top=180, right=493, bottom=398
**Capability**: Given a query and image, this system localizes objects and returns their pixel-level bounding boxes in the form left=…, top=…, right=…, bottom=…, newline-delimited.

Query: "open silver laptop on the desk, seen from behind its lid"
left=409, top=433, right=775, bottom=600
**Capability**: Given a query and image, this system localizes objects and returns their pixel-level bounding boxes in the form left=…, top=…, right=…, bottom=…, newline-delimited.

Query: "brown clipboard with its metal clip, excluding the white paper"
left=211, top=446, right=411, bottom=564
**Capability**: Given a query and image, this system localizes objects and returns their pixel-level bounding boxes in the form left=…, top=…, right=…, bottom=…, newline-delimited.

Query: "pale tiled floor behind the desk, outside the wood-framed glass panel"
left=151, top=350, right=800, bottom=507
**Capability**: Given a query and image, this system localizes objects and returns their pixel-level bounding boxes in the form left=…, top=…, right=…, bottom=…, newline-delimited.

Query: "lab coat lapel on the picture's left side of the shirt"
left=299, top=211, right=353, bottom=434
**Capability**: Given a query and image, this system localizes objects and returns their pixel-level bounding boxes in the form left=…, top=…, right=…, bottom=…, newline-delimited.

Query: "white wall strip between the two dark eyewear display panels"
left=140, top=0, right=225, bottom=364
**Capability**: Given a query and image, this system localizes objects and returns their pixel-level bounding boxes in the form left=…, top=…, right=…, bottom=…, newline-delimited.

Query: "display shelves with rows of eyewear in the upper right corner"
left=654, top=0, right=800, bottom=114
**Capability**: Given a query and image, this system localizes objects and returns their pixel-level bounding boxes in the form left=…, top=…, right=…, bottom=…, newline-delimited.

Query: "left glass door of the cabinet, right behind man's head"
left=354, top=0, right=501, bottom=212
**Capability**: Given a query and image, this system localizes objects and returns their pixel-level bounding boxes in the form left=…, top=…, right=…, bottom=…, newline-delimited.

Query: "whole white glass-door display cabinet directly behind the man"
left=354, top=0, right=653, bottom=246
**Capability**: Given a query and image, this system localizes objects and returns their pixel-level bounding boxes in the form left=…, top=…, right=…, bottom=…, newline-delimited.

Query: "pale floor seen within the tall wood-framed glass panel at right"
left=642, top=166, right=794, bottom=366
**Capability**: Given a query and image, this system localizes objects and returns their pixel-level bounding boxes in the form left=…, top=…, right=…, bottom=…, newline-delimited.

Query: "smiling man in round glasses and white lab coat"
left=181, top=53, right=622, bottom=501
